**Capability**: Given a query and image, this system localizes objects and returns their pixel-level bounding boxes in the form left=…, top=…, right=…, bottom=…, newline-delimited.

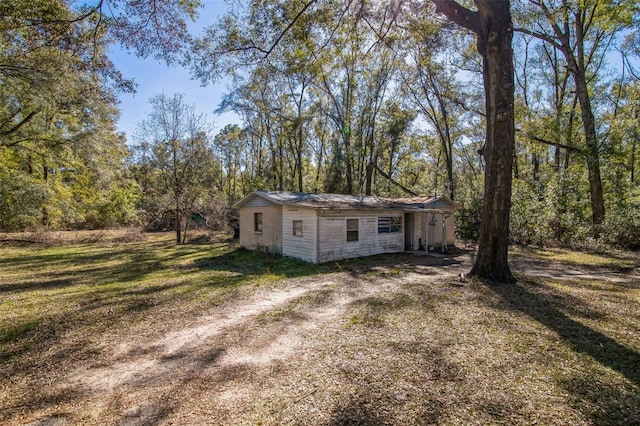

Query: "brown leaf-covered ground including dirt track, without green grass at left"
left=0, top=235, right=640, bottom=425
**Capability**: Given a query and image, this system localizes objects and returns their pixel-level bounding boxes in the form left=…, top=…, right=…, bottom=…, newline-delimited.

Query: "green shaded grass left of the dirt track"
left=0, top=231, right=328, bottom=365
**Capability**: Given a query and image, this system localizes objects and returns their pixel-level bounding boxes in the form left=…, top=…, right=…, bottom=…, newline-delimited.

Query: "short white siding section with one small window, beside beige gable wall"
left=282, top=206, right=318, bottom=263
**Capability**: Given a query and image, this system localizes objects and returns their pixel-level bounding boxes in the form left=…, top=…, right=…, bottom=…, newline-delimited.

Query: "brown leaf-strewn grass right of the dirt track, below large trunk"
left=240, top=272, right=640, bottom=425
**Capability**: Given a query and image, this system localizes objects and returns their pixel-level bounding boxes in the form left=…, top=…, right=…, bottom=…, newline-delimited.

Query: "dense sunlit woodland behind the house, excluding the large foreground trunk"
left=0, top=0, right=640, bottom=249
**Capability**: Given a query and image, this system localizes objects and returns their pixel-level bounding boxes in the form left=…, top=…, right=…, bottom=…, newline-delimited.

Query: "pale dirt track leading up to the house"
left=23, top=255, right=468, bottom=425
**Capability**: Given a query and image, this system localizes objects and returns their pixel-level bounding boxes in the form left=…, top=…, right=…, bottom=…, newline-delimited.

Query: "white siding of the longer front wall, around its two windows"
left=318, top=210, right=404, bottom=262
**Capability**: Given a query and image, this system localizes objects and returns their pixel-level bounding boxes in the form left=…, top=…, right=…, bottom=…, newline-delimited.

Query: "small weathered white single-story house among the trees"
left=234, top=191, right=459, bottom=263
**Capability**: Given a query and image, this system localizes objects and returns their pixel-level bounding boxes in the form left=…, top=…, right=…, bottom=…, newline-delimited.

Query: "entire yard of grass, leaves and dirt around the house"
left=0, top=231, right=640, bottom=425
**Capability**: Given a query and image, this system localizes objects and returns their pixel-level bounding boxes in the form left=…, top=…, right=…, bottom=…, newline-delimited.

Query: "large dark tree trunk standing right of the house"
left=432, top=0, right=515, bottom=283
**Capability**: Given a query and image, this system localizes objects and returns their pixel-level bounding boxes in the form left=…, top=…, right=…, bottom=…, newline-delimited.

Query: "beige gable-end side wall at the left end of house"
left=240, top=197, right=282, bottom=253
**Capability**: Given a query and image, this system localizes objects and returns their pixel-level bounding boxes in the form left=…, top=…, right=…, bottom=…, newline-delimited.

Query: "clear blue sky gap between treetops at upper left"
left=109, top=0, right=240, bottom=143
